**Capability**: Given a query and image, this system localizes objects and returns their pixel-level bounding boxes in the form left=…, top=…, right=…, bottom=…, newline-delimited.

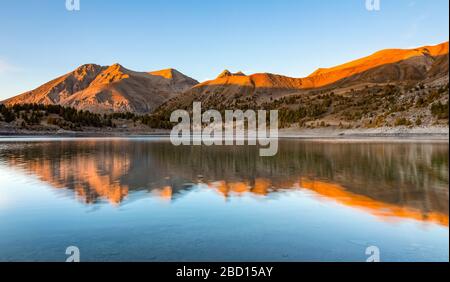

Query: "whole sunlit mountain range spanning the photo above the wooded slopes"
left=2, top=42, right=449, bottom=117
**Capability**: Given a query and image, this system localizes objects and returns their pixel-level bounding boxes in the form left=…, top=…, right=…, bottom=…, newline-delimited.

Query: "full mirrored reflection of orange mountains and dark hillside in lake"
left=0, top=139, right=449, bottom=225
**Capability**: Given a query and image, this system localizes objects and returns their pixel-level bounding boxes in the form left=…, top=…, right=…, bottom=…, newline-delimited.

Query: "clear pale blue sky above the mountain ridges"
left=0, top=0, right=449, bottom=99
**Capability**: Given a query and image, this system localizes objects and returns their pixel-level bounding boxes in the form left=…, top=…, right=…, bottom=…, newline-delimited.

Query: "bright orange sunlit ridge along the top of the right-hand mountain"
left=195, top=42, right=448, bottom=92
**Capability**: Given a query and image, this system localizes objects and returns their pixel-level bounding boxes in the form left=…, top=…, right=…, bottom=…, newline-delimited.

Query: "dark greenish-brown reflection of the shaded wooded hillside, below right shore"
left=147, top=141, right=448, bottom=211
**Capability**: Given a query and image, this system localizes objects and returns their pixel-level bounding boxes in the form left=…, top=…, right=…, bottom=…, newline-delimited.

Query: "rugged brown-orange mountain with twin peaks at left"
left=4, top=64, right=198, bottom=113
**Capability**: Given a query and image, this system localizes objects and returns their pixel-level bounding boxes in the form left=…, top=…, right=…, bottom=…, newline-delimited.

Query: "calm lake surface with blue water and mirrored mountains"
left=0, top=138, right=449, bottom=261
